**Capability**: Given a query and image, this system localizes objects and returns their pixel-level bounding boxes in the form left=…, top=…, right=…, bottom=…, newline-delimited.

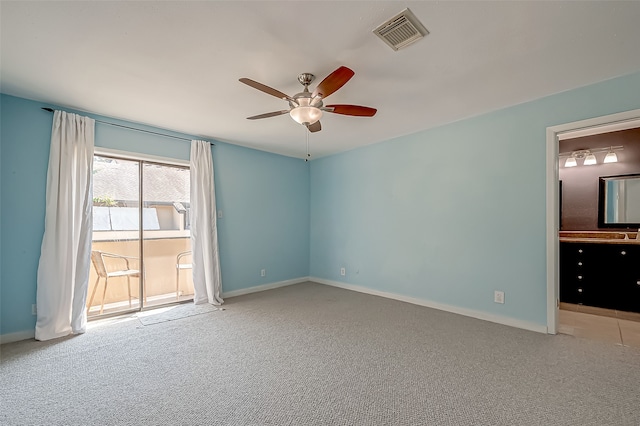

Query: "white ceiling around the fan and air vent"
left=0, top=1, right=640, bottom=157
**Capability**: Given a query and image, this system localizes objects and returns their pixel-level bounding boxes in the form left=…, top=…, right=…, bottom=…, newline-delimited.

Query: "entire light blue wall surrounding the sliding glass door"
left=0, top=95, right=309, bottom=335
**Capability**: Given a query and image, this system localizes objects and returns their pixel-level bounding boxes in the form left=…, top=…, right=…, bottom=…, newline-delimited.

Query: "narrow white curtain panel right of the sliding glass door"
left=190, top=140, right=223, bottom=305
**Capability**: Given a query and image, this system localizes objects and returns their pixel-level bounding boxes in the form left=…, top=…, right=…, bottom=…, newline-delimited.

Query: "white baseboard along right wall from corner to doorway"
left=309, top=277, right=547, bottom=334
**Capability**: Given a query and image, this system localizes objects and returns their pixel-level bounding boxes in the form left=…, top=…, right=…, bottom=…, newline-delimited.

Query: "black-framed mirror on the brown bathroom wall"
left=598, top=174, right=640, bottom=228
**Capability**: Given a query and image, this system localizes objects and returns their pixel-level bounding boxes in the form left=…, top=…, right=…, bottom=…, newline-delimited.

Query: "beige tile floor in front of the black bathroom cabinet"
left=558, top=303, right=640, bottom=348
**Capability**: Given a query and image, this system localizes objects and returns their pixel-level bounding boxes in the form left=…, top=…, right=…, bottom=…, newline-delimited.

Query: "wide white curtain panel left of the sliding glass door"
left=35, top=111, right=95, bottom=340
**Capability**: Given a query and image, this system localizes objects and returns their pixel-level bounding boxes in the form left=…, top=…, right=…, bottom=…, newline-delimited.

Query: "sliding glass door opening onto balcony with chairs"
left=87, top=155, right=193, bottom=318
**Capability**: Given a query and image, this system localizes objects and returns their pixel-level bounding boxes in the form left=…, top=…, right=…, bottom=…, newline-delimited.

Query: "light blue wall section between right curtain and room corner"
left=214, top=144, right=310, bottom=292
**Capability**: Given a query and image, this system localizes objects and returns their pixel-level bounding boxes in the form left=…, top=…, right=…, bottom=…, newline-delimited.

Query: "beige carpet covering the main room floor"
left=0, top=283, right=640, bottom=426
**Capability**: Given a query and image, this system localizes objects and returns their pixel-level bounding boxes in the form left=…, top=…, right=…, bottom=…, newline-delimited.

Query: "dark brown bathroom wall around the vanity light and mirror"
left=559, top=128, right=640, bottom=231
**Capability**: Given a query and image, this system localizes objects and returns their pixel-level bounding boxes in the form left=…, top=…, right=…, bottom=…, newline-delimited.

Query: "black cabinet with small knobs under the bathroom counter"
left=560, top=242, right=640, bottom=312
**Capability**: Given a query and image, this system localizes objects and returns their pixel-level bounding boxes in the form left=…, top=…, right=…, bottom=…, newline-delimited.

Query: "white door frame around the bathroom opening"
left=547, top=109, right=640, bottom=334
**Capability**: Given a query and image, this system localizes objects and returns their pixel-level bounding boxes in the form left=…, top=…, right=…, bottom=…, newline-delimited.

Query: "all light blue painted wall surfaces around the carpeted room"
left=0, top=73, right=640, bottom=340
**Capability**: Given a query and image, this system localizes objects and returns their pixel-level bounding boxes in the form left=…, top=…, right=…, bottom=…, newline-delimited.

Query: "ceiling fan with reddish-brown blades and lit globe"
left=240, top=66, right=377, bottom=132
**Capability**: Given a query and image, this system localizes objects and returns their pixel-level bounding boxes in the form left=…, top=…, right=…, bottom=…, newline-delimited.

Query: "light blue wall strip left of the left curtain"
left=0, top=95, right=52, bottom=334
